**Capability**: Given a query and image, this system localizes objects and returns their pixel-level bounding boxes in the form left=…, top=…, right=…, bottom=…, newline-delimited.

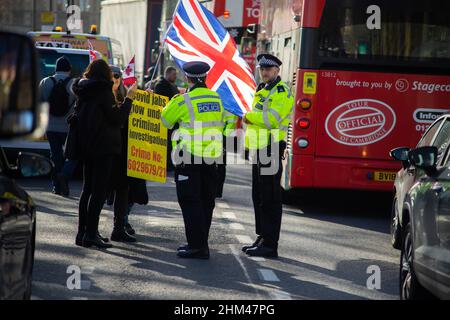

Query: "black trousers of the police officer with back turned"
left=175, top=164, right=217, bottom=249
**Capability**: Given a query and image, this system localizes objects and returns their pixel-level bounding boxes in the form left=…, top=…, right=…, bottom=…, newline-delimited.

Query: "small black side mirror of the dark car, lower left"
left=17, top=152, right=53, bottom=178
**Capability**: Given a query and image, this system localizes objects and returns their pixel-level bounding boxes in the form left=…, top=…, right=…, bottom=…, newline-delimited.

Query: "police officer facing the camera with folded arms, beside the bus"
left=242, top=54, right=294, bottom=257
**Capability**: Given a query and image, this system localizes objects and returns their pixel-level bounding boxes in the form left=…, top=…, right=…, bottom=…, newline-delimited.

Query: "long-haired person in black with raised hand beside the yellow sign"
left=73, top=59, right=136, bottom=248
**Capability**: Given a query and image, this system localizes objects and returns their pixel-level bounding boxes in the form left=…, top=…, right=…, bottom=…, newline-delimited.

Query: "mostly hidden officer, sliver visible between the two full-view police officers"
left=216, top=110, right=239, bottom=198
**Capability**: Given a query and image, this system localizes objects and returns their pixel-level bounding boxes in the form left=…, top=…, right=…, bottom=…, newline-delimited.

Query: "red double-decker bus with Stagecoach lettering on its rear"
left=258, top=0, right=450, bottom=190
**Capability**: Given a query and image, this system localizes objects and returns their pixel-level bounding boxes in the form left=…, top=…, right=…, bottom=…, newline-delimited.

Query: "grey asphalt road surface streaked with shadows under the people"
left=19, top=155, right=400, bottom=300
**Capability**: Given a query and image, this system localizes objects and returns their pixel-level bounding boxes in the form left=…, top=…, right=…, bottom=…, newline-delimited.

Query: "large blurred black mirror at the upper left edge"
left=0, top=31, right=46, bottom=138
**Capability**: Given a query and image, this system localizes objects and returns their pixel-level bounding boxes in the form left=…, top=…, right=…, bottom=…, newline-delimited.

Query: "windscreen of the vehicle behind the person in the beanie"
left=38, top=50, right=89, bottom=79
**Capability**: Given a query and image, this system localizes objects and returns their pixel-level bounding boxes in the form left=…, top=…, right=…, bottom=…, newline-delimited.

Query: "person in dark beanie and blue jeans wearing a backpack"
left=39, top=56, right=77, bottom=197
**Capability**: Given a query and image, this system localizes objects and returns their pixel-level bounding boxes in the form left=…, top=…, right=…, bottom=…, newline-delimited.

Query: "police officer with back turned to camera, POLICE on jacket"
left=161, top=62, right=224, bottom=259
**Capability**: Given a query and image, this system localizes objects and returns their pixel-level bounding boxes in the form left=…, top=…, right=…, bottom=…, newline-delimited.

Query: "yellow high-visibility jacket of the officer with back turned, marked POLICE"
left=161, top=86, right=224, bottom=158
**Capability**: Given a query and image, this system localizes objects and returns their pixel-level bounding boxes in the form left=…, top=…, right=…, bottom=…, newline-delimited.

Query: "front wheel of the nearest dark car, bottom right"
left=399, top=223, right=430, bottom=300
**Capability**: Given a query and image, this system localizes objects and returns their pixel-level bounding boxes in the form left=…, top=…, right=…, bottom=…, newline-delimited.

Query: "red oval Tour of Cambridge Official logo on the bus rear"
left=325, top=99, right=396, bottom=146
